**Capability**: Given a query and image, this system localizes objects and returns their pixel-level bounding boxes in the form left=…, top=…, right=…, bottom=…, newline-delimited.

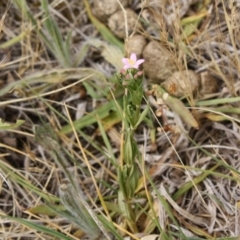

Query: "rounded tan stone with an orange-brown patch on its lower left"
left=162, top=70, right=200, bottom=97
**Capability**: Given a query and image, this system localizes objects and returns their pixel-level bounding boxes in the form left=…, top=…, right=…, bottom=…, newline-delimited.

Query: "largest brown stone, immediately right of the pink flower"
left=143, top=41, right=178, bottom=84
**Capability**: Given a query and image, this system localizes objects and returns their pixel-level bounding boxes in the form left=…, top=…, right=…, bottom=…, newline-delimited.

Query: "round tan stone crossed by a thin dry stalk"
left=108, top=8, right=141, bottom=38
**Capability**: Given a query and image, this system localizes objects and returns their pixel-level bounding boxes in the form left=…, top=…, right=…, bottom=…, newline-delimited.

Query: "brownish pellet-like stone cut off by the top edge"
left=93, top=0, right=128, bottom=22
